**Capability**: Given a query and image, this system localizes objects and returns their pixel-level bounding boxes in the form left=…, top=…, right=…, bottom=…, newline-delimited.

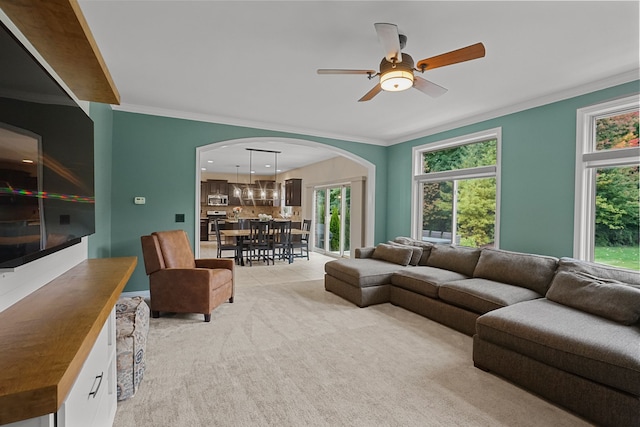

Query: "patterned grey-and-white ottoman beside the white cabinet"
left=116, top=297, right=149, bottom=400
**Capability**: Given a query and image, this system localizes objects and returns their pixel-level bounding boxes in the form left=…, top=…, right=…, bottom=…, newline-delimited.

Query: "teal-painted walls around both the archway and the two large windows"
left=102, top=81, right=640, bottom=291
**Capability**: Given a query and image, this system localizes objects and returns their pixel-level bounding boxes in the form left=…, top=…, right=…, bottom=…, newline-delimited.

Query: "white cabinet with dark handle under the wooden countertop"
left=2, top=309, right=118, bottom=427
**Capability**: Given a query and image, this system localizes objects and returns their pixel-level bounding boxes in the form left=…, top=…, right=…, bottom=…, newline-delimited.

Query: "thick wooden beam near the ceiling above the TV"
left=0, top=0, right=120, bottom=105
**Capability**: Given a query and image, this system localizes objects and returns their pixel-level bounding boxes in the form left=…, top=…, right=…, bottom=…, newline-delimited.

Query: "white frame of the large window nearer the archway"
left=411, top=127, right=502, bottom=249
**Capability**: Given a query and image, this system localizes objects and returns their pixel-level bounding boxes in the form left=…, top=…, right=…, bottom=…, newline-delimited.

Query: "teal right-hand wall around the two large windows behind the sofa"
left=386, top=81, right=640, bottom=256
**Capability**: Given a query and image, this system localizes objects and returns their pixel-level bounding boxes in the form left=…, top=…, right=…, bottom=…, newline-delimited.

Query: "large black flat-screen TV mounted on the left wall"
left=0, top=23, right=95, bottom=269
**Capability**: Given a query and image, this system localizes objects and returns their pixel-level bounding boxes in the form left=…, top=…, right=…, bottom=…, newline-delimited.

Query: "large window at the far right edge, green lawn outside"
left=573, top=95, right=640, bottom=270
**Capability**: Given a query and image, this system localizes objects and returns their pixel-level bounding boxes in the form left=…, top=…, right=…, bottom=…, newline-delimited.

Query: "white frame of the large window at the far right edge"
left=573, top=94, right=640, bottom=261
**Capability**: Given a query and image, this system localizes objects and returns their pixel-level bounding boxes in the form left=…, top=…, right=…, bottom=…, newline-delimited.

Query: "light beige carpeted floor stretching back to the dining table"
left=114, top=261, right=588, bottom=427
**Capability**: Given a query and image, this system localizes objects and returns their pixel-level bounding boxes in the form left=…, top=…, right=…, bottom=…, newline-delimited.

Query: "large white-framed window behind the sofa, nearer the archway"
left=412, top=129, right=501, bottom=247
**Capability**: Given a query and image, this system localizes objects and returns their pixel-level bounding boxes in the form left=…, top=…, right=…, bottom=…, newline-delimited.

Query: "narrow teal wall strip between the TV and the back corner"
left=88, top=103, right=113, bottom=258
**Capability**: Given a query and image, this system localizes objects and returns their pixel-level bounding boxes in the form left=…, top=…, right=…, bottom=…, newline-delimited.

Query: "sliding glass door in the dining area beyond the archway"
left=314, top=184, right=351, bottom=257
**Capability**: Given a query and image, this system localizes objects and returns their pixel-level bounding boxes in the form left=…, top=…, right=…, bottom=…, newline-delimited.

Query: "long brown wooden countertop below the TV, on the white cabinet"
left=0, top=257, right=137, bottom=424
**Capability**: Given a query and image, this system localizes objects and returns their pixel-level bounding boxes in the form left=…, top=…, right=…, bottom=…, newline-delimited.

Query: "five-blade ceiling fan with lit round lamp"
left=318, top=23, right=485, bottom=102
